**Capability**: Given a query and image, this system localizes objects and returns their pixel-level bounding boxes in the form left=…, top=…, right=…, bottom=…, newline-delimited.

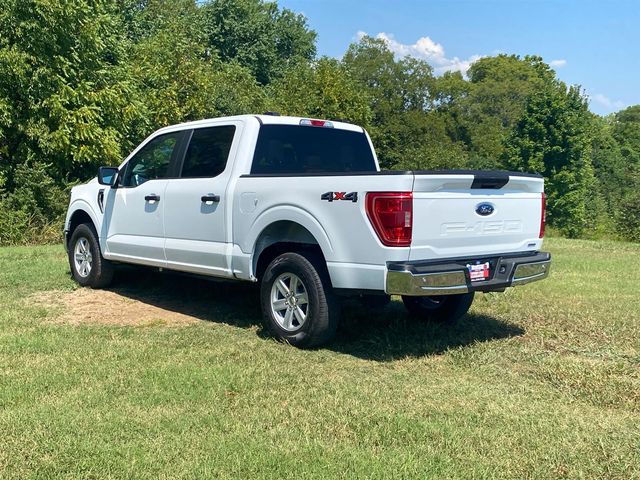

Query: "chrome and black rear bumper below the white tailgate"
left=385, top=252, right=551, bottom=296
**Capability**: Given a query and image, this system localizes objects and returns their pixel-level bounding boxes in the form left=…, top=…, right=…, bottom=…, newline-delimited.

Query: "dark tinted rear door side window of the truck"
left=182, top=125, right=236, bottom=178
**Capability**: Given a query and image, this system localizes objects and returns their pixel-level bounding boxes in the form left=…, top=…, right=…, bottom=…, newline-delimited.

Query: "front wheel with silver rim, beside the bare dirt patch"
left=69, top=223, right=114, bottom=288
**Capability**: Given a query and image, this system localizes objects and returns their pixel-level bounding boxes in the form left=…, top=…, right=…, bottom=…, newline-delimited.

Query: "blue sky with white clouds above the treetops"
left=278, top=0, right=640, bottom=115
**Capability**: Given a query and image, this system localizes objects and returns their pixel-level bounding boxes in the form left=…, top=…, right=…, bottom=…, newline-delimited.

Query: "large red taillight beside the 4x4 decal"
left=366, top=192, right=413, bottom=247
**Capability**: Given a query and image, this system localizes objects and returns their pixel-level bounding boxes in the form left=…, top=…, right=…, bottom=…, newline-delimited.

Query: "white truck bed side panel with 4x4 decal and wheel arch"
left=232, top=174, right=413, bottom=289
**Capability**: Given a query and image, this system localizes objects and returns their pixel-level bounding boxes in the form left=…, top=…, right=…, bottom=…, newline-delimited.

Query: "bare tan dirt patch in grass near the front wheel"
left=29, top=288, right=198, bottom=326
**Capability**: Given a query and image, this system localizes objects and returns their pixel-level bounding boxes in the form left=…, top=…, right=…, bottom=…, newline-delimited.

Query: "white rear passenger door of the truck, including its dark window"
left=164, top=121, right=242, bottom=277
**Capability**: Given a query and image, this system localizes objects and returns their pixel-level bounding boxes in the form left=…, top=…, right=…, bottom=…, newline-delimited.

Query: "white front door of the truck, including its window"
left=101, top=132, right=184, bottom=266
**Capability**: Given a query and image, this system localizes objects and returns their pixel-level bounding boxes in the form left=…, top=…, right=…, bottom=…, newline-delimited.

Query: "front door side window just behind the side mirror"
left=121, top=132, right=182, bottom=187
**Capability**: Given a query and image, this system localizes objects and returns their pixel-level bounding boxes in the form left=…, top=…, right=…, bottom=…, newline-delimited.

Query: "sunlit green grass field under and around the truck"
left=0, top=239, right=640, bottom=479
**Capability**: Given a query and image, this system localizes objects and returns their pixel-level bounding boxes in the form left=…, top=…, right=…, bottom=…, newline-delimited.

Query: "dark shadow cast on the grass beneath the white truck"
left=110, top=269, right=524, bottom=361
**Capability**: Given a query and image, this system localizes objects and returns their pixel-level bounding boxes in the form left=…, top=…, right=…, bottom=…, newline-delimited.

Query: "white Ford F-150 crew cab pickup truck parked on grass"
left=65, top=114, right=551, bottom=347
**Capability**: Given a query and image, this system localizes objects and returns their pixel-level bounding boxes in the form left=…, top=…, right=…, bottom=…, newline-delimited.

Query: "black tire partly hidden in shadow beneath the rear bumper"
left=402, top=292, right=474, bottom=323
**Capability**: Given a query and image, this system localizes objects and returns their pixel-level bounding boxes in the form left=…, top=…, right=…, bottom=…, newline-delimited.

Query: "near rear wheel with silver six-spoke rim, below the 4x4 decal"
left=260, top=253, right=339, bottom=348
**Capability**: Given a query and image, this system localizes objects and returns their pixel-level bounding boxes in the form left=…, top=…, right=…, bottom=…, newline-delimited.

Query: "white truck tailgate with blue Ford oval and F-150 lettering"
left=409, top=172, right=544, bottom=260
